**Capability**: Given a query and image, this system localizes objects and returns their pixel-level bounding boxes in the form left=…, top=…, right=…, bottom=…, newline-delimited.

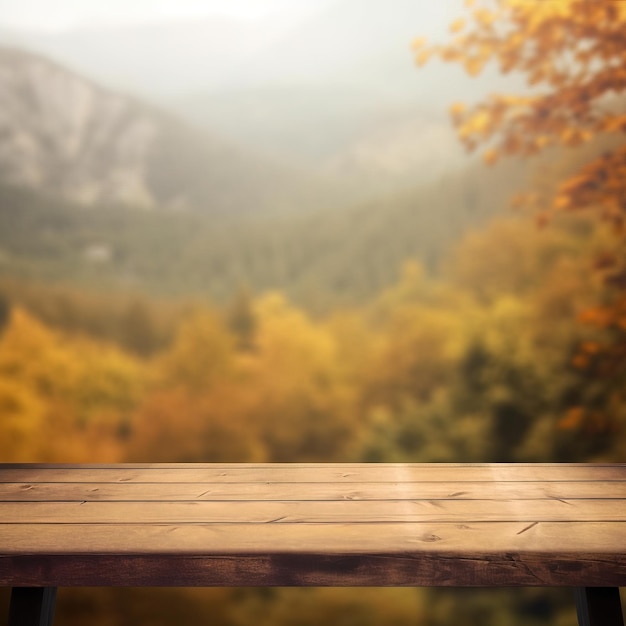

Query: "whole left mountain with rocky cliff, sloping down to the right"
left=0, top=48, right=338, bottom=214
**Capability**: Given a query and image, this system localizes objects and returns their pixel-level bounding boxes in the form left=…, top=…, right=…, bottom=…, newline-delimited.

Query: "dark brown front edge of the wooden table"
left=0, top=551, right=624, bottom=587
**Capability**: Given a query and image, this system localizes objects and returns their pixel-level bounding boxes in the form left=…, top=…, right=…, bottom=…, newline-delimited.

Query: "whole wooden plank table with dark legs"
left=0, top=464, right=626, bottom=626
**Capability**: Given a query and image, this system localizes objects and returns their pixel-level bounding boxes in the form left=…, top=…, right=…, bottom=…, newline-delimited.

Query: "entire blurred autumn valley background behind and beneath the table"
left=0, top=0, right=626, bottom=626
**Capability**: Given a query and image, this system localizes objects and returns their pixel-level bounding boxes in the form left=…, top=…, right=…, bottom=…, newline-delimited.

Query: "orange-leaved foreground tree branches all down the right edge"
left=414, top=0, right=626, bottom=438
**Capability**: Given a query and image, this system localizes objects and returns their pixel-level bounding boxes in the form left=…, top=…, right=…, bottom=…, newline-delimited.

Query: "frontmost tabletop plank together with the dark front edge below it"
left=0, top=524, right=626, bottom=586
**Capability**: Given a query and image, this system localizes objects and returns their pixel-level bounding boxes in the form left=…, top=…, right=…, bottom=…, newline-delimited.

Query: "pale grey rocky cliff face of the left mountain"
left=0, top=48, right=158, bottom=206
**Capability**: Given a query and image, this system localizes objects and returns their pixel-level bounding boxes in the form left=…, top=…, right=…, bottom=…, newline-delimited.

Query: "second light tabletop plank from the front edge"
left=0, top=499, right=626, bottom=525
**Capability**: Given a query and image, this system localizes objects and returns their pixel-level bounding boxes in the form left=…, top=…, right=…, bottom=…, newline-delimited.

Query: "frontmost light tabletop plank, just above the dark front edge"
left=0, top=522, right=626, bottom=556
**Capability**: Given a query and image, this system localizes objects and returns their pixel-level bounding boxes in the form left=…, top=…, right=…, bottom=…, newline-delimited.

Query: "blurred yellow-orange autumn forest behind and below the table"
left=0, top=207, right=626, bottom=626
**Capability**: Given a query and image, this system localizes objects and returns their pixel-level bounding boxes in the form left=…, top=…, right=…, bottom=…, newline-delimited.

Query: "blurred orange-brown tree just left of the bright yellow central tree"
left=127, top=310, right=262, bottom=462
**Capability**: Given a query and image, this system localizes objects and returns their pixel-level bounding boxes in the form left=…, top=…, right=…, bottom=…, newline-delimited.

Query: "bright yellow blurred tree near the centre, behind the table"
left=240, top=293, right=355, bottom=462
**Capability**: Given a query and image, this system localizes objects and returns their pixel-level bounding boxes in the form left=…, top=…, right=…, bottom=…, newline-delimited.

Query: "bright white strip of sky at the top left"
left=0, top=0, right=321, bottom=32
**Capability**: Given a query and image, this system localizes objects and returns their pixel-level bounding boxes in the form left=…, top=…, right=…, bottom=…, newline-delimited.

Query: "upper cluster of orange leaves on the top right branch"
left=417, top=0, right=626, bottom=154
